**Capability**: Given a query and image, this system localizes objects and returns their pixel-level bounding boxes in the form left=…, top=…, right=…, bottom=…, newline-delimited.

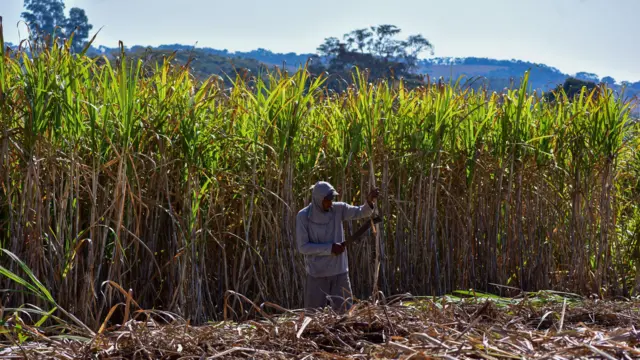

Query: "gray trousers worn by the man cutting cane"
left=304, top=273, right=352, bottom=313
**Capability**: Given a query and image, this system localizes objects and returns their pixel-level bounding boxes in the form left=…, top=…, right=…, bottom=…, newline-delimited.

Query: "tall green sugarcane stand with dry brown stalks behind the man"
left=0, top=24, right=640, bottom=329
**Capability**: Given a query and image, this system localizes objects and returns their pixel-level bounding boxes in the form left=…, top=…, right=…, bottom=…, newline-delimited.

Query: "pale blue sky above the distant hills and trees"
left=0, top=0, right=640, bottom=82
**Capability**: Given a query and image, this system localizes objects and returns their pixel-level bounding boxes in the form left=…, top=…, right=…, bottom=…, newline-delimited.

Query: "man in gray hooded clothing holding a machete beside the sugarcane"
left=296, top=181, right=379, bottom=312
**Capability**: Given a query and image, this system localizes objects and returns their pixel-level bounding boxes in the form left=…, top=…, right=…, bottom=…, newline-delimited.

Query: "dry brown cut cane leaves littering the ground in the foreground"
left=0, top=298, right=640, bottom=359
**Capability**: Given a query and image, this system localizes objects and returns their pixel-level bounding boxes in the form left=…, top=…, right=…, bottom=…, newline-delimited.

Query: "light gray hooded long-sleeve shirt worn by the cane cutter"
left=296, top=183, right=373, bottom=277
